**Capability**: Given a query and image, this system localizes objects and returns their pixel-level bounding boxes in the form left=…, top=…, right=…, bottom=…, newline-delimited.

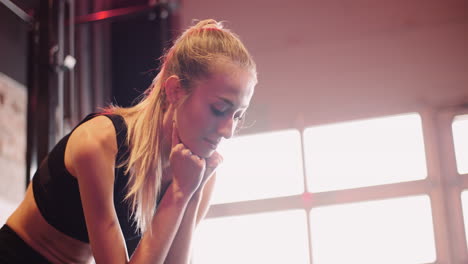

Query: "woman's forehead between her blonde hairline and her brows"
left=193, top=63, right=255, bottom=107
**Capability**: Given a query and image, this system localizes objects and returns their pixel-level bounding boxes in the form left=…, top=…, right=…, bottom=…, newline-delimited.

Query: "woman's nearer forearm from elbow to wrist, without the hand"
left=130, top=184, right=191, bottom=264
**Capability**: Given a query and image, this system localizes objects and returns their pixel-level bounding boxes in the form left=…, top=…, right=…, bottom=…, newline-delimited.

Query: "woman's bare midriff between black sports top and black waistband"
left=6, top=184, right=92, bottom=263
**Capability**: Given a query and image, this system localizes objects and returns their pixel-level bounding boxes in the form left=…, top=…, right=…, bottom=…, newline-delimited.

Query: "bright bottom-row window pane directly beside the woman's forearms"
left=194, top=210, right=309, bottom=264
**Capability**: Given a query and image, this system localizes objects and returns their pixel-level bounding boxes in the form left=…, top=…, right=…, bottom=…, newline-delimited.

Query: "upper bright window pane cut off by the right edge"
left=452, top=115, right=468, bottom=174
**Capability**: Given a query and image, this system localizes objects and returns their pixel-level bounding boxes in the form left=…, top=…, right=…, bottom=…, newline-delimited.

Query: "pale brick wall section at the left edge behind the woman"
left=0, top=73, right=27, bottom=224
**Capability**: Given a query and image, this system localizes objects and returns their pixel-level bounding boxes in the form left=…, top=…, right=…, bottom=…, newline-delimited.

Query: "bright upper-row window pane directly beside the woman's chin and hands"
left=213, top=130, right=304, bottom=203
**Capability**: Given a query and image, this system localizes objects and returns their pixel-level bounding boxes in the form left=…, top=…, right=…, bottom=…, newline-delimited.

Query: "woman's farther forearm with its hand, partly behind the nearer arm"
left=164, top=172, right=216, bottom=264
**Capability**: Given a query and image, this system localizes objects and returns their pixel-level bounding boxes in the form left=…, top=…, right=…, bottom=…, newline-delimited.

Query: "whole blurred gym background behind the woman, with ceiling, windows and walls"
left=0, top=0, right=468, bottom=264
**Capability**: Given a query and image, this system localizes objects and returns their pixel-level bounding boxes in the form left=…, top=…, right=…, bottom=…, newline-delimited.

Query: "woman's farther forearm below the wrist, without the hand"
left=164, top=191, right=202, bottom=264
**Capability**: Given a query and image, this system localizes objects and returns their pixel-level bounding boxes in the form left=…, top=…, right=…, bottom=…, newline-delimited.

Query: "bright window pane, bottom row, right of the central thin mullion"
left=310, top=196, right=436, bottom=264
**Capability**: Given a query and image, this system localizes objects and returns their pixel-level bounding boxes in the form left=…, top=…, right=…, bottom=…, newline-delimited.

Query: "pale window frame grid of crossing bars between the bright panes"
left=206, top=106, right=468, bottom=264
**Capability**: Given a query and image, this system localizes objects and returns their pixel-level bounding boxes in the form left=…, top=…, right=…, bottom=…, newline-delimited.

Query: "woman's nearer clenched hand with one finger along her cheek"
left=169, top=122, right=206, bottom=195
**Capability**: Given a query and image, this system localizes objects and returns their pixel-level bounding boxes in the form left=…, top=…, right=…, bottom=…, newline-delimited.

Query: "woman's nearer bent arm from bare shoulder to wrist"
left=67, top=117, right=199, bottom=264
